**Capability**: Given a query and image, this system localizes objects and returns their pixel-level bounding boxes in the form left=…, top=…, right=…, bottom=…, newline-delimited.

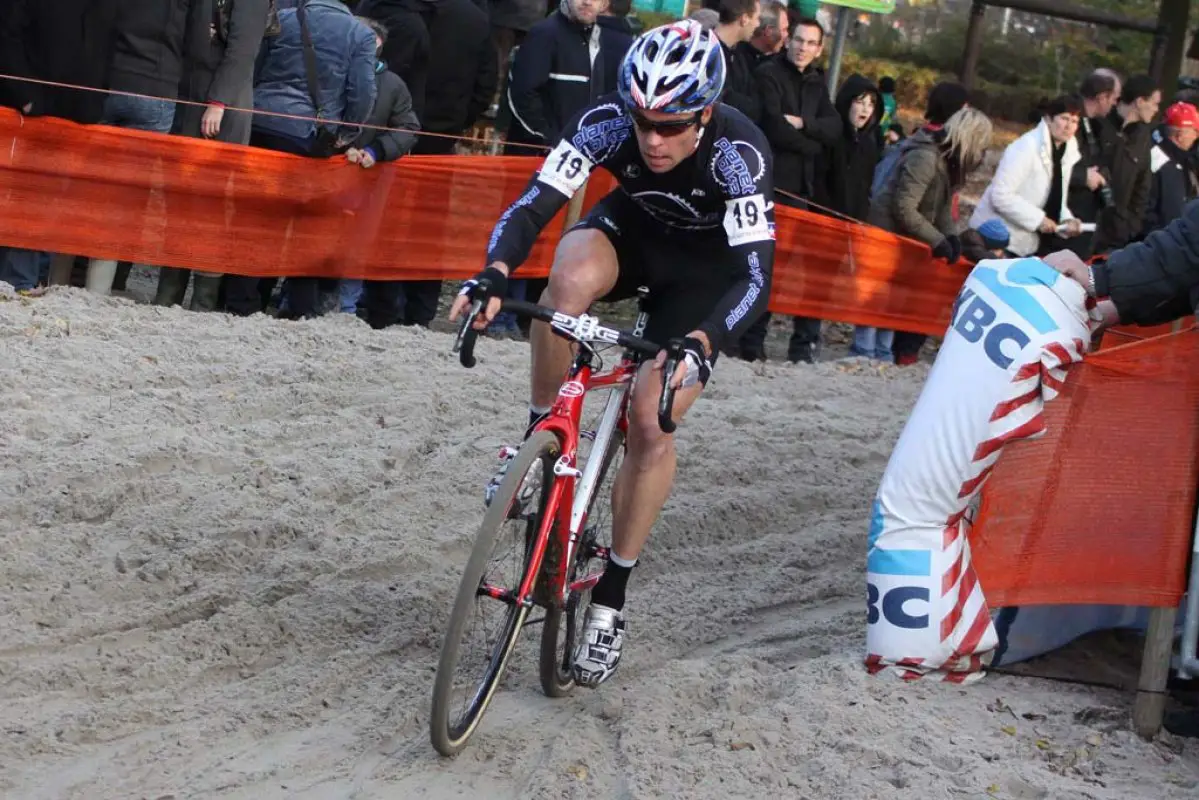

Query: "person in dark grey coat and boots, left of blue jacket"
left=155, top=0, right=278, bottom=311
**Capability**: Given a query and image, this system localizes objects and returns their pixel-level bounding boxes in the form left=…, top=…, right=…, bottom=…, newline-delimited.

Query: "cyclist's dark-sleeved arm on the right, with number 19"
left=699, top=138, right=775, bottom=355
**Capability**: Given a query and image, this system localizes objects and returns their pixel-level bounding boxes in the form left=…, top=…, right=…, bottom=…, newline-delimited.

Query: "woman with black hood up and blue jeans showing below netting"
left=827, top=74, right=892, bottom=361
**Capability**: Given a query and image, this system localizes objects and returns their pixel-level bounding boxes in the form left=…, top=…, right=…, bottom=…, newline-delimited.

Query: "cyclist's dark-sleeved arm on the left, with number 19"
left=487, top=106, right=609, bottom=271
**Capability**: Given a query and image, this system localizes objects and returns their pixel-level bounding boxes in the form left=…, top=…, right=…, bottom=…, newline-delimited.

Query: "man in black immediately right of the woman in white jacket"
left=1065, top=70, right=1121, bottom=259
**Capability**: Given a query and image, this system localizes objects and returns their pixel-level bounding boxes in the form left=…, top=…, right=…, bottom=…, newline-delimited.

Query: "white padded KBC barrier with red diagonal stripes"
left=867, top=258, right=1091, bottom=681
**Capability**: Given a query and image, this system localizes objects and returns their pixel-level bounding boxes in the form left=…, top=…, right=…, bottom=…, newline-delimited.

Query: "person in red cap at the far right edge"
left=1144, top=103, right=1199, bottom=234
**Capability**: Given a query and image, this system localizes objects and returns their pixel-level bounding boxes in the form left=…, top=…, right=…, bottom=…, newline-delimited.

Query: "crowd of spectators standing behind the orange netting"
left=0, top=0, right=1199, bottom=363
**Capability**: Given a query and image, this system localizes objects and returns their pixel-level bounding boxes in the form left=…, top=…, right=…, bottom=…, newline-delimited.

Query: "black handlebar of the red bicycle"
left=452, top=297, right=682, bottom=433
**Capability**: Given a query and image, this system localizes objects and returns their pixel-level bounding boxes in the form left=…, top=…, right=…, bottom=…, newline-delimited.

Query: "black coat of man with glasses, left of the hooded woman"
left=754, top=59, right=842, bottom=206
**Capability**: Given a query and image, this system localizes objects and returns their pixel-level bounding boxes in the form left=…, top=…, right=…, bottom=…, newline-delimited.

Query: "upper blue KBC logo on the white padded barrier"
left=952, top=258, right=1060, bottom=369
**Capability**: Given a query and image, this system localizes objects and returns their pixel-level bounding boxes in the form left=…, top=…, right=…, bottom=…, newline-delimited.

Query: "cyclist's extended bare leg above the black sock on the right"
left=611, top=363, right=704, bottom=561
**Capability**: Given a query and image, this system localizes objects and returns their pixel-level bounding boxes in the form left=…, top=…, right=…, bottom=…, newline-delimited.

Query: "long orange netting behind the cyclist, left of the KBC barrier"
left=0, top=110, right=965, bottom=335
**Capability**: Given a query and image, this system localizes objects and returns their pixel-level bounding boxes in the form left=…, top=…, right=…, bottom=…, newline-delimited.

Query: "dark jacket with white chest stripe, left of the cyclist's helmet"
left=506, top=12, right=633, bottom=146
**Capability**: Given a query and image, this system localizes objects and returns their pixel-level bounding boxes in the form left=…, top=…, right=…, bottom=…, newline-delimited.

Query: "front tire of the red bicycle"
left=429, top=431, right=561, bottom=756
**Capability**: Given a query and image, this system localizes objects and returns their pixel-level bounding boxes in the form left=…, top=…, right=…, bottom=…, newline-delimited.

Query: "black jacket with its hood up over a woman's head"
left=827, top=74, right=884, bottom=222
